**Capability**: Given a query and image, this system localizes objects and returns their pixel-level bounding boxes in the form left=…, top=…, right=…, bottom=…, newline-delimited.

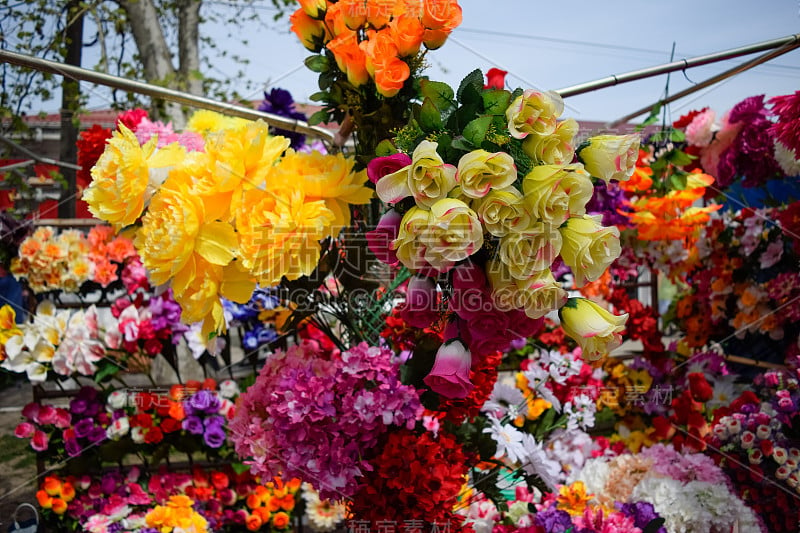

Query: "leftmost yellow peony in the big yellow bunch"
left=83, top=124, right=186, bottom=230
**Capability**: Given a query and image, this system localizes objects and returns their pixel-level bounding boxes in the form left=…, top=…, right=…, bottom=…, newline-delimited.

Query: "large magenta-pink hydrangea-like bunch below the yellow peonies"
left=230, top=343, right=422, bottom=499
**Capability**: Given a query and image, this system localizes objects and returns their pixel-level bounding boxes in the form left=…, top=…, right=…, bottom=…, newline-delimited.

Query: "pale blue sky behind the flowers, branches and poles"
left=64, top=0, right=800, bottom=121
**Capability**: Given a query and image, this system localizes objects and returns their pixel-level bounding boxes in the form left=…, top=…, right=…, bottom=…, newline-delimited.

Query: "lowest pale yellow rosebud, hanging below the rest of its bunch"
left=559, top=298, right=628, bottom=361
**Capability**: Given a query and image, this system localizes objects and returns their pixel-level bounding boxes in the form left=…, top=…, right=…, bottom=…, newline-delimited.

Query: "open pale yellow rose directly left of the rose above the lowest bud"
left=498, top=222, right=561, bottom=279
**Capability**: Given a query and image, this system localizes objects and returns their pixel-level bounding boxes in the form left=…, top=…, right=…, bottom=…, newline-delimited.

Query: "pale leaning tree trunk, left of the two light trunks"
left=118, top=0, right=186, bottom=129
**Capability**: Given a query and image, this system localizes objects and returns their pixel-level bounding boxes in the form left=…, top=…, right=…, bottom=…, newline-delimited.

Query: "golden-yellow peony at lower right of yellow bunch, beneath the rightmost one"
left=236, top=189, right=336, bottom=286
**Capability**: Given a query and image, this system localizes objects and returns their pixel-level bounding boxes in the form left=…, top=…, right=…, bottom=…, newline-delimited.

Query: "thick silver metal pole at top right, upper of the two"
left=556, top=33, right=800, bottom=98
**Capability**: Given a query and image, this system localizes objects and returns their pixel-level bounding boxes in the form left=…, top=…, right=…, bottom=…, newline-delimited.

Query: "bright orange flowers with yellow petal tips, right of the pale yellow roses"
left=624, top=170, right=722, bottom=241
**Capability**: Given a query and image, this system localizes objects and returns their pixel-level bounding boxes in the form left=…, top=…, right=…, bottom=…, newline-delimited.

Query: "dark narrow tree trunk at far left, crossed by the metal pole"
left=58, top=0, right=83, bottom=218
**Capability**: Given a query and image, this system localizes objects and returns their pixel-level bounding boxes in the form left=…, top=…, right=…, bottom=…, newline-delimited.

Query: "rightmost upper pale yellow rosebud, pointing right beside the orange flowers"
left=578, top=134, right=640, bottom=182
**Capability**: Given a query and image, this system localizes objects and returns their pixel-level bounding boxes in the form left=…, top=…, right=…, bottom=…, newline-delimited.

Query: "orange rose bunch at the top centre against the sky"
left=290, top=0, right=461, bottom=98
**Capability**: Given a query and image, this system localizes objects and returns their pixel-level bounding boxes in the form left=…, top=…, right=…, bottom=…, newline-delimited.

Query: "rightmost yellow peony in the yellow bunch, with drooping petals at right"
left=267, top=149, right=372, bottom=237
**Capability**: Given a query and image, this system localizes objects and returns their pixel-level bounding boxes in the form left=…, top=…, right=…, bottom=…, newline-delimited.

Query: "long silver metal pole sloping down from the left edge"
left=0, top=50, right=334, bottom=143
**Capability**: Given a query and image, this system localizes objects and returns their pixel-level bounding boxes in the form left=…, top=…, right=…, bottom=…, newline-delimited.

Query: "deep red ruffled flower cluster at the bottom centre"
left=351, top=429, right=468, bottom=533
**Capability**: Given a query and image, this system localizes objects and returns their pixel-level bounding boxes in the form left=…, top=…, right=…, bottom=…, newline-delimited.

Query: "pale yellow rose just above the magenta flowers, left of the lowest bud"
left=486, top=259, right=567, bottom=319
